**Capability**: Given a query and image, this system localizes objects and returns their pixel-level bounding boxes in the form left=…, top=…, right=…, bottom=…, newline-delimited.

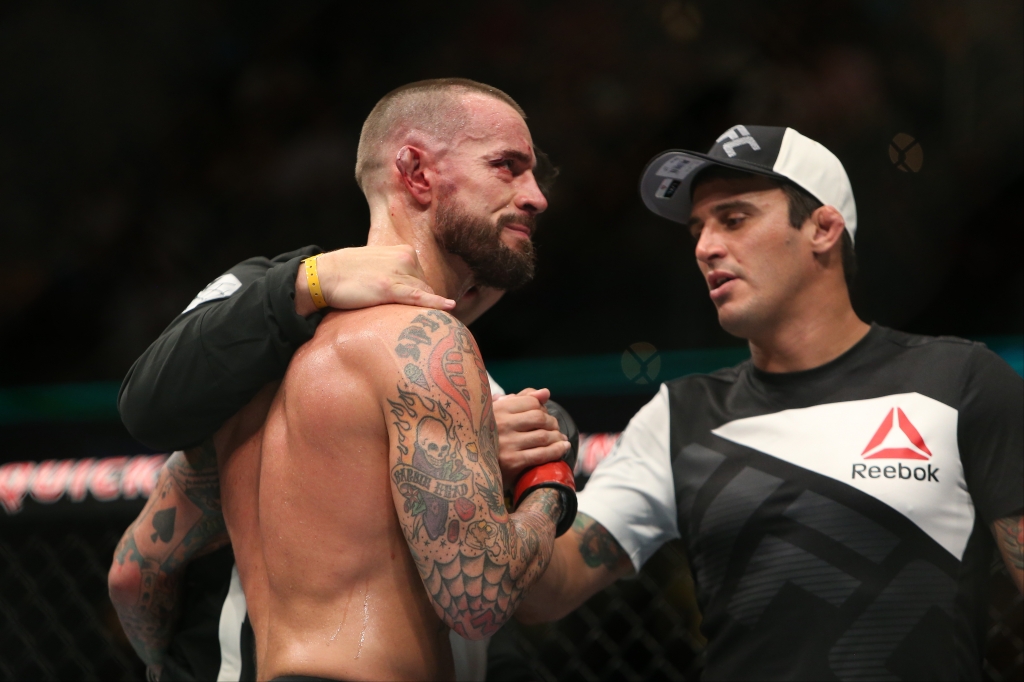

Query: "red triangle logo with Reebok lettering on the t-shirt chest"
left=851, top=408, right=939, bottom=483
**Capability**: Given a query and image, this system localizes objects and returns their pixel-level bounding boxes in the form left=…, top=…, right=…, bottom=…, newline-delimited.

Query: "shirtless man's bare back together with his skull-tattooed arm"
left=215, top=305, right=561, bottom=680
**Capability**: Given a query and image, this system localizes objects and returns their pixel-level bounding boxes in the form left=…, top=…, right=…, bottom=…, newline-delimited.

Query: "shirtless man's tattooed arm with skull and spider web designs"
left=382, top=310, right=561, bottom=639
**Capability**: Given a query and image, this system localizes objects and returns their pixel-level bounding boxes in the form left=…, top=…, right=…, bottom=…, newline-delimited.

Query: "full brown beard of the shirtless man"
left=435, top=193, right=537, bottom=291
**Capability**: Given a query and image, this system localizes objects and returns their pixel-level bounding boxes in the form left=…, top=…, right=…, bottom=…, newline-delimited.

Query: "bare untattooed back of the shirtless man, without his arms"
left=215, top=310, right=454, bottom=680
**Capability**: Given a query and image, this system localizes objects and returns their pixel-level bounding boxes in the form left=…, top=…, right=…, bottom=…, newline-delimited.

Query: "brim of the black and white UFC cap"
left=640, top=150, right=786, bottom=225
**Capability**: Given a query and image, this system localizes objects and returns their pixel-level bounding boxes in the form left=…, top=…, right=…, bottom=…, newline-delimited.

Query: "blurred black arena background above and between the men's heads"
left=0, top=0, right=1024, bottom=386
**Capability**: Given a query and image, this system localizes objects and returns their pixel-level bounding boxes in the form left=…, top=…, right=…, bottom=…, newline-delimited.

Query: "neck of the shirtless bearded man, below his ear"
left=367, top=197, right=473, bottom=301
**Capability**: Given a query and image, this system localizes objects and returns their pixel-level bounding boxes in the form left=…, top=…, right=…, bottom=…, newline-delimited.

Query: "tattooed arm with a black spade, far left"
left=108, top=445, right=227, bottom=666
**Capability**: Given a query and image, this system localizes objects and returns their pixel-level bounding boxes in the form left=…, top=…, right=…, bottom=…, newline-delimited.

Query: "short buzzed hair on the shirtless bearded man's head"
left=355, top=78, right=526, bottom=193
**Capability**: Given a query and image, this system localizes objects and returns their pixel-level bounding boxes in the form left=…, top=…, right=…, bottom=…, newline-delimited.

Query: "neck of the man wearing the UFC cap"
left=749, top=287, right=870, bottom=373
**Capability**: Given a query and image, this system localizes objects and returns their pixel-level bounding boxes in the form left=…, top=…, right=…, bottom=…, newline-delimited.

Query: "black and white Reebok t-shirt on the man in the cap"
left=580, top=326, right=1024, bottom=680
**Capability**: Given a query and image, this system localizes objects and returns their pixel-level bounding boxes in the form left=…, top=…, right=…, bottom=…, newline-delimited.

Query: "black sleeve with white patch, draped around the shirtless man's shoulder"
left=118, top=246, right=323, bottom=452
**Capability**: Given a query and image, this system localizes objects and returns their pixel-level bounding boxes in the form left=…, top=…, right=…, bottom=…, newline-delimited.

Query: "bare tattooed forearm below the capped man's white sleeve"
left=516, top=513, right=633, bottom=624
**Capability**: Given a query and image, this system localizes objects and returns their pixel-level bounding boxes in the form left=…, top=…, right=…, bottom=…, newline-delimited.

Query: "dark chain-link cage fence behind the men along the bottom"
left=0, top=491, right=1024, bottom=681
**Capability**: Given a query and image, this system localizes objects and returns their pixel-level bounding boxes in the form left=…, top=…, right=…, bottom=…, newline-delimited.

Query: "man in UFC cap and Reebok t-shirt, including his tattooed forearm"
left=518, top=125, right=1024, bottom=680
